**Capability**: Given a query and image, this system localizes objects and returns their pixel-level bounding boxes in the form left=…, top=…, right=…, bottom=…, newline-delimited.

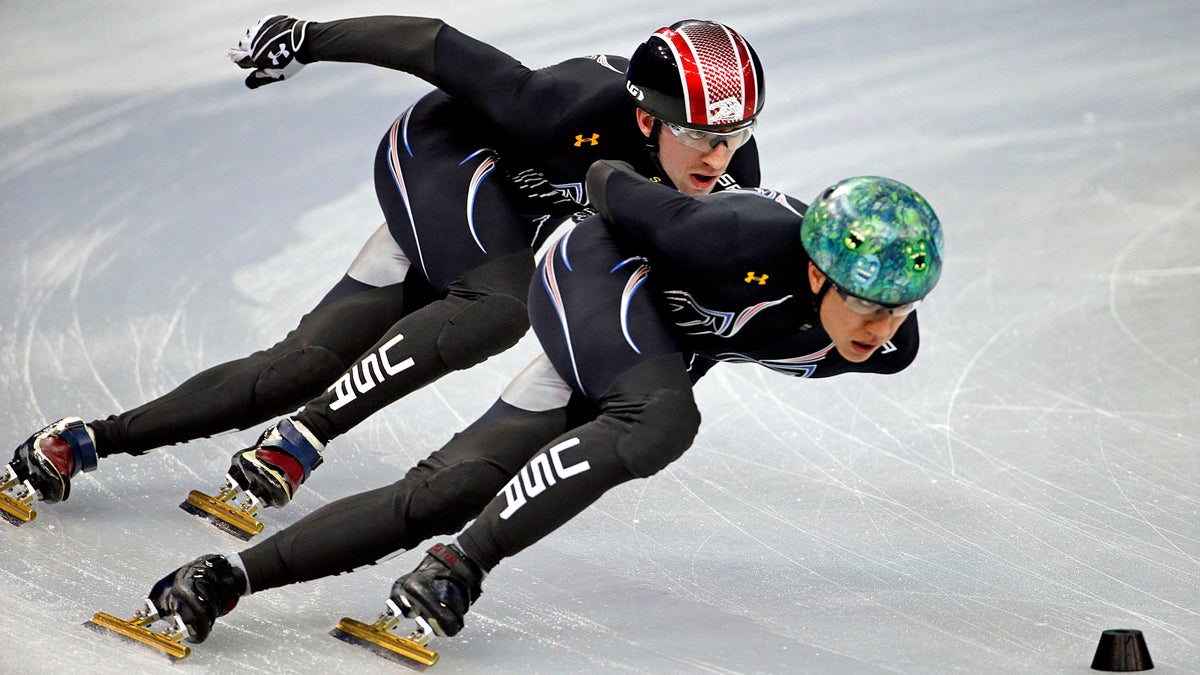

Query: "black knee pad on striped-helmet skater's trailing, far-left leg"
left=254, top=346, right=346, bottom=416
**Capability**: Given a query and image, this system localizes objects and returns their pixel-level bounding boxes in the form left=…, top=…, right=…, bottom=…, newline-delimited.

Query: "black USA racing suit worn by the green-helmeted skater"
left=241, top=165, right=919, bottom=590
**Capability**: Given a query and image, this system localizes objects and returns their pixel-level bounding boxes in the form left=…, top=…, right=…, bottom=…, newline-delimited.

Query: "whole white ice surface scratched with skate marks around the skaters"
left=0, top=0, right=1200, bottom=673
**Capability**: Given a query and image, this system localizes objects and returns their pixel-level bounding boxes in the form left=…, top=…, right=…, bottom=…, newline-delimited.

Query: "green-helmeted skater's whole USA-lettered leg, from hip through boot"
left=391, top=221, right=700, bottom=635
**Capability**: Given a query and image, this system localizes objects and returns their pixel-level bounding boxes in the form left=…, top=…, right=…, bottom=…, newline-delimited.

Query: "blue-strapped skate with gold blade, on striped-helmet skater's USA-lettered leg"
left=179, top=419, right=325, bottom=540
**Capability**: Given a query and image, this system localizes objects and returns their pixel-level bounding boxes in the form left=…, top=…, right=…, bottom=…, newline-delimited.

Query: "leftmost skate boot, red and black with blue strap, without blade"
left=8, top=417, right=97, bottom=504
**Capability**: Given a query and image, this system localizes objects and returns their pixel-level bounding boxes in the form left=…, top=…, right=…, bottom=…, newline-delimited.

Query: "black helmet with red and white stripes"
left=625, top=19, right=766, bottom=131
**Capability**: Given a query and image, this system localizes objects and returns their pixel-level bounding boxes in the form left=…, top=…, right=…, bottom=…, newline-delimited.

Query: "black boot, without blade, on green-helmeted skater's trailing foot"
left=149, top=555, right=246, bottom=643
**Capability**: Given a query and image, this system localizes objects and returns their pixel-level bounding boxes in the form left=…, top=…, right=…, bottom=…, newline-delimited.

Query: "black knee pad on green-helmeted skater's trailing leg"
left=404, top=460, right=510, bottom=538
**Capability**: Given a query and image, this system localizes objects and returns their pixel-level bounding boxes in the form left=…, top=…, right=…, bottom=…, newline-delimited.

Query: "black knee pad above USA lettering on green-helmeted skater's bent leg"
left=611, top=389, right=700, bottom=478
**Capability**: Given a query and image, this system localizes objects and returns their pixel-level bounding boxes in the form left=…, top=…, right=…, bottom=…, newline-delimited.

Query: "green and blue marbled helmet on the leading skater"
left=800, top=175, right=944, bottom=306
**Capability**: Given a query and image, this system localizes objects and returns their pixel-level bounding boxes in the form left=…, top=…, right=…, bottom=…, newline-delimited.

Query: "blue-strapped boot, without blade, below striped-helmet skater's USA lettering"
left=229, top=418, right=325, bottom=507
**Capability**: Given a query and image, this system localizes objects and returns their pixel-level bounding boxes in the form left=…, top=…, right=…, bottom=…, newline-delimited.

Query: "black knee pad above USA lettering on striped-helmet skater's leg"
left=437, top=293, right=529, bottom=370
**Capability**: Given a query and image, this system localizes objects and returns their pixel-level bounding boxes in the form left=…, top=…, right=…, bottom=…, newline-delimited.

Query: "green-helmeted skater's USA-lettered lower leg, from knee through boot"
left=391, top=354, right=700, bottom=635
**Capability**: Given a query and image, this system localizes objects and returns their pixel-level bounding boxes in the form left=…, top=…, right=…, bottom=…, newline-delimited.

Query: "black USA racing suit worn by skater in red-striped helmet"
left=91, top=17, right=758, bottom=456
